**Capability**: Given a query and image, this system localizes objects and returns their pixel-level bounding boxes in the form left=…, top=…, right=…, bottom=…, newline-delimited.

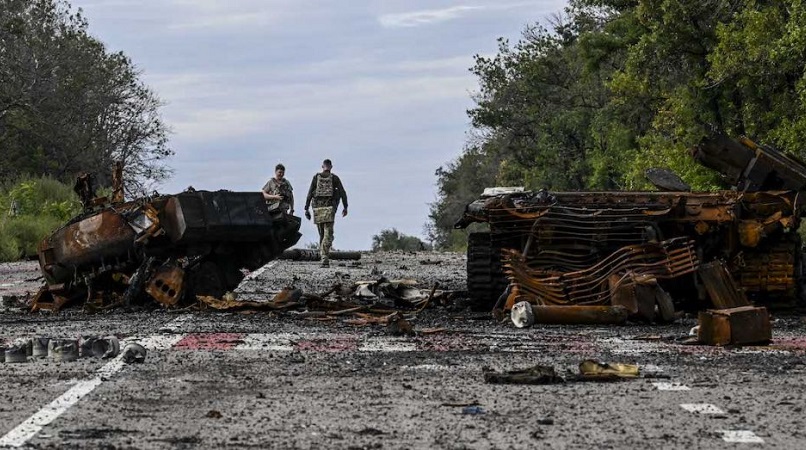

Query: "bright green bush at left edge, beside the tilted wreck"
left=0, top=177, right=81, bottom=261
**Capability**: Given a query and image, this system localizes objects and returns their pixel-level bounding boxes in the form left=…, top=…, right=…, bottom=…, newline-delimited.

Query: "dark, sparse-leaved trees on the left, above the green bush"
left=0, top=0, right=173, bottom=195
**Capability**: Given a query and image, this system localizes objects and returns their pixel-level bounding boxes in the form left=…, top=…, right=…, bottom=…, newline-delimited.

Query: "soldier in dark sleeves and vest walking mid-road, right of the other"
left=305, top=159, right=347, bottom=267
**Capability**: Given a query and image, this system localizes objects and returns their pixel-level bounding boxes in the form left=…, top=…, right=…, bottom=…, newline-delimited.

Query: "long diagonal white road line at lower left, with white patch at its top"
left=0, top=335, right=183, bottom=447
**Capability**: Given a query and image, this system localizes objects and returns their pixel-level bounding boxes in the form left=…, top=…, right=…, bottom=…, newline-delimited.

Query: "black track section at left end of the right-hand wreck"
left=467, top=233, right=509, bottom=311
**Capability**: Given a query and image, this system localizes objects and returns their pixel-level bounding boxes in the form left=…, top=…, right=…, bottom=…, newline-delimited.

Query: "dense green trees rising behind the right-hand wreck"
left=426, top=0, right=806, bottom=249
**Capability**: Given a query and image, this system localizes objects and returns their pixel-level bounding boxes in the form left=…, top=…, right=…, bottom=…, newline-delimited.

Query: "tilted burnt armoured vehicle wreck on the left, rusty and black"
left=33, top=190, right=301, bottom=310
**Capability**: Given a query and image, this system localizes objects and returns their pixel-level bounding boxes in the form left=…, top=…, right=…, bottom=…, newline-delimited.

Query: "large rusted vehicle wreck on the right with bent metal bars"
left=455, top=136, right=806, bottom=319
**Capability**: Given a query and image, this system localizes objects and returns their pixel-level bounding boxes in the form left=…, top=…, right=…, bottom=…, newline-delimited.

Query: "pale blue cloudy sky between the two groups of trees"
left=71, top=0, right=566, bottom=249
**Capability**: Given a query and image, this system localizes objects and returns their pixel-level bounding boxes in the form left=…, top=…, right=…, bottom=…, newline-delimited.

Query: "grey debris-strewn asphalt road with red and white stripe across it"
left=0, top=253, right=806, bottom=449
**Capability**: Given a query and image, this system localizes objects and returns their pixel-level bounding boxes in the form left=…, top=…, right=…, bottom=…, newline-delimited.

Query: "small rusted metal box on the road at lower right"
left=697, top=306, right=772, bottom=345
